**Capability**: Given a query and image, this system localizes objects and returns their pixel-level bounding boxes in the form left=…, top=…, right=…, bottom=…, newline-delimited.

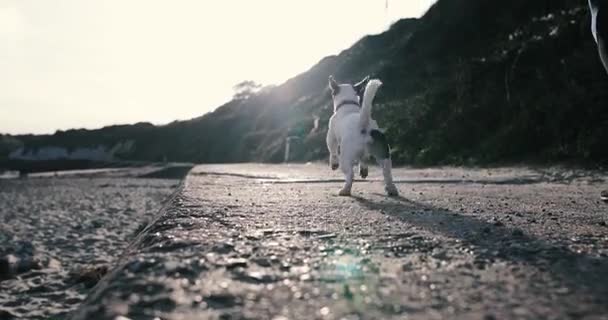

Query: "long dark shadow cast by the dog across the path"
left=352, top=194, right=608, bottom=304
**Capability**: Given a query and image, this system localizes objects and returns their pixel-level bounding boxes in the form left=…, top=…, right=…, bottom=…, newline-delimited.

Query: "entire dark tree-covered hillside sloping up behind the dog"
left=0, top=0, right=608, bottom=169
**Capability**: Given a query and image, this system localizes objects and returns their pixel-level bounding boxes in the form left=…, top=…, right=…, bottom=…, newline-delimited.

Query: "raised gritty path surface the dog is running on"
left=73, top=165, right=608, bottom=320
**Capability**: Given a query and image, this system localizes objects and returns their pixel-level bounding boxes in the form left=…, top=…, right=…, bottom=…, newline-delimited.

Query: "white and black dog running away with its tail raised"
left=327, top=76, right=399, bottom=196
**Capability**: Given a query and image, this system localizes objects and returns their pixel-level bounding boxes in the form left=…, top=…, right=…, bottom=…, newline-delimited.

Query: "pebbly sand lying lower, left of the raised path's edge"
left=0, top=172, right=179, bottom=319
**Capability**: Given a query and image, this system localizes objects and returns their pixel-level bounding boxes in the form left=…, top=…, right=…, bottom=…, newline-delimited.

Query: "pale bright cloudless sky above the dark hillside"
left=0, top=0, right=434, bottom=134
